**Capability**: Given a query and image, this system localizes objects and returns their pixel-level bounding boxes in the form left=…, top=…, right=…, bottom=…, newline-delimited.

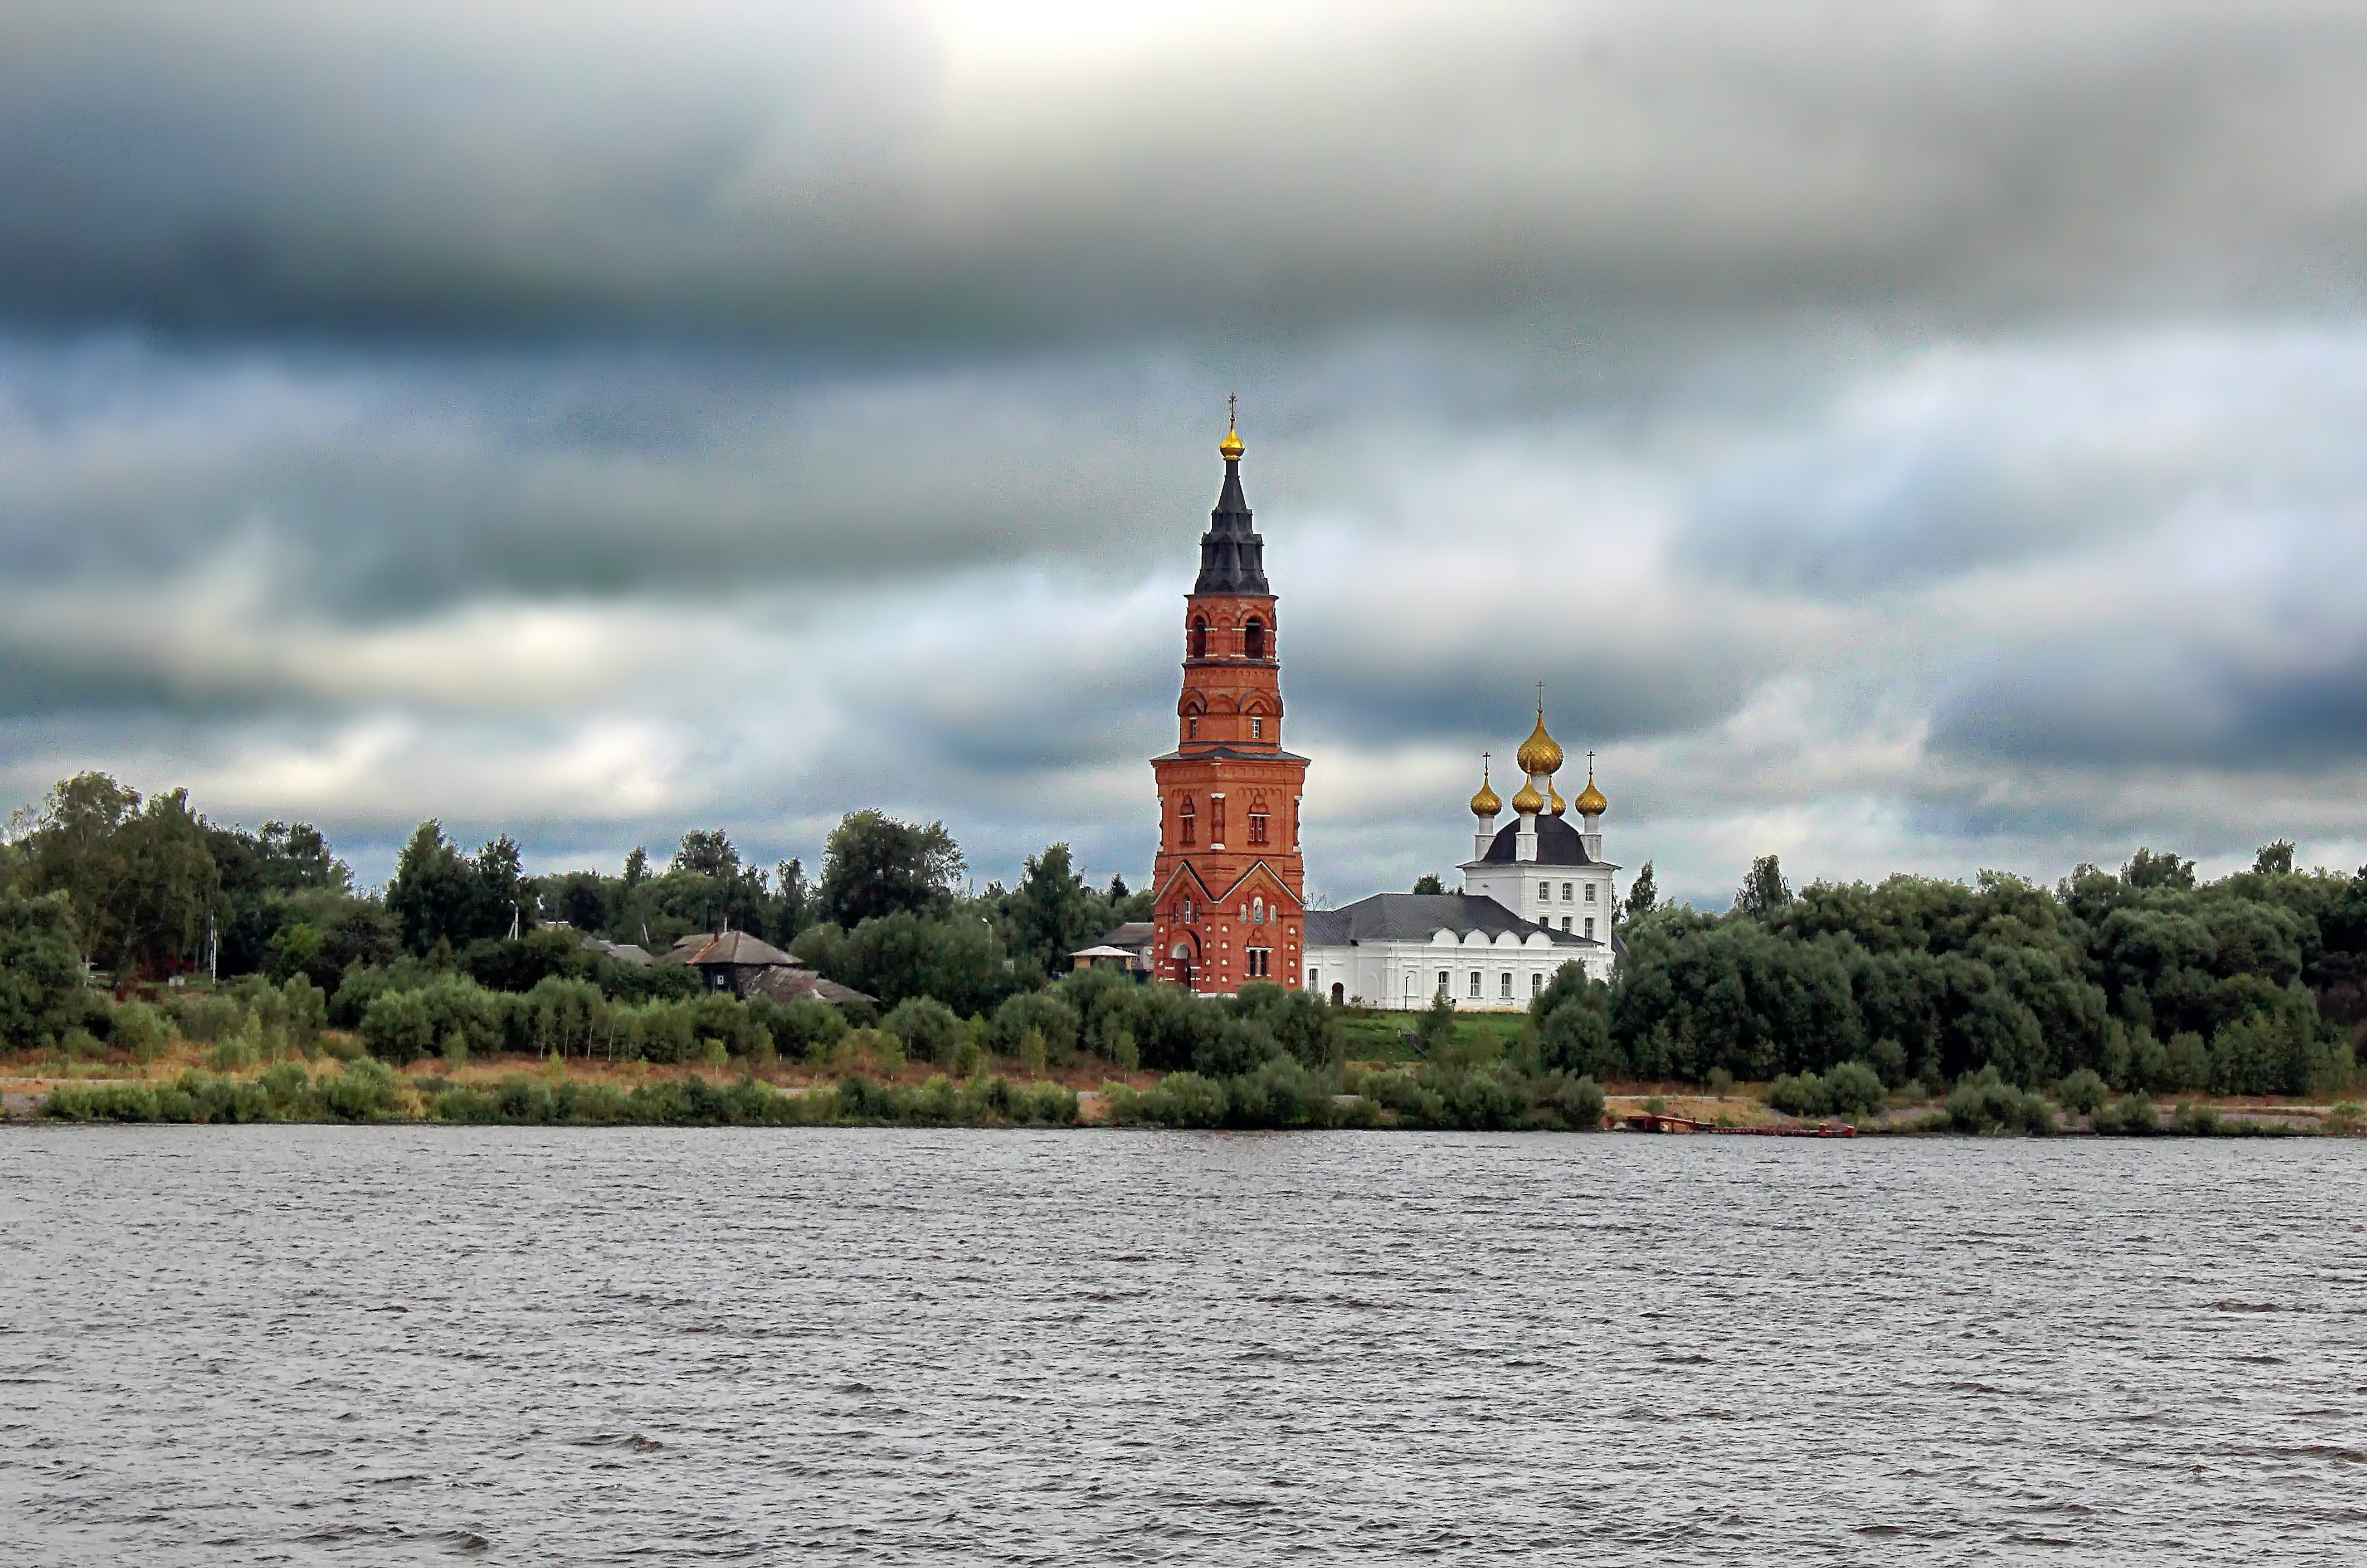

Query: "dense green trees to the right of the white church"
left=1536, top=841, right=2367, bottom=1094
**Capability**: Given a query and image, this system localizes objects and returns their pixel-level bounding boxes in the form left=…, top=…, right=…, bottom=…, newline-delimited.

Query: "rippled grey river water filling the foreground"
left=0, top=1127, right=2367, bottom=1566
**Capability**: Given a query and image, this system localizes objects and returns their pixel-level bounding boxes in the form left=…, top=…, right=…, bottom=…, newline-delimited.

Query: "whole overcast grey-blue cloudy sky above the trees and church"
left=0, top=0, right=2367, bottom=905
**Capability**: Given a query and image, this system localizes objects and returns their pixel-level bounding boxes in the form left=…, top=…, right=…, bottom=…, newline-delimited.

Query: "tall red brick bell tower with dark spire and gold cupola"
left=1151, top=405, right=1307, bottom=992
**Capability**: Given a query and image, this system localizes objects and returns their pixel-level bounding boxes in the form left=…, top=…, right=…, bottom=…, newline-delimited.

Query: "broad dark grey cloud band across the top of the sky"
left=0, top=2, right=2367, bottom=348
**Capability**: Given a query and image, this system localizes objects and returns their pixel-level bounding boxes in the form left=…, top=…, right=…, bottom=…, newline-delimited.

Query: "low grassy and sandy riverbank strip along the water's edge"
left=0, top=1042, right=2363, bottom=1137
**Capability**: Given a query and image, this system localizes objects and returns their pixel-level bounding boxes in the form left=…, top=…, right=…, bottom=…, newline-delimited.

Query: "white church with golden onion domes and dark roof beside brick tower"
left=1302, top=706, right=1621, bottom=1011
